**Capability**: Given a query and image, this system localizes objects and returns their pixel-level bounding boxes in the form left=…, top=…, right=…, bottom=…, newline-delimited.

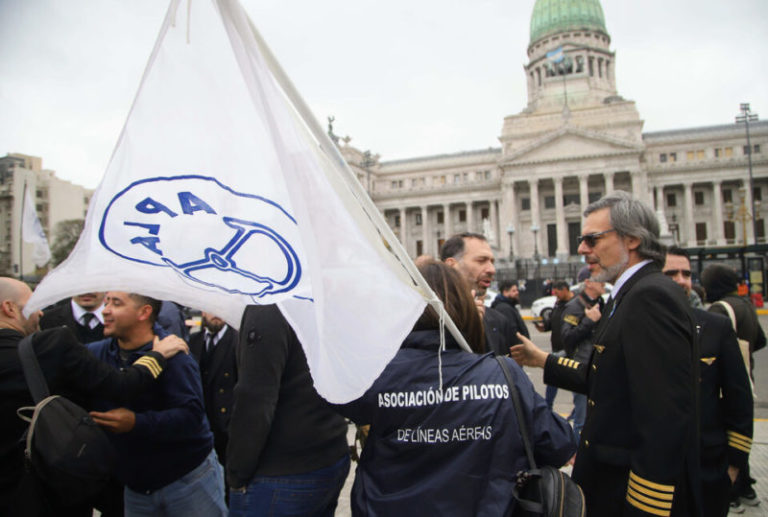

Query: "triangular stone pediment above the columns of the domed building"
left=501, top=128, right=643, bottom=165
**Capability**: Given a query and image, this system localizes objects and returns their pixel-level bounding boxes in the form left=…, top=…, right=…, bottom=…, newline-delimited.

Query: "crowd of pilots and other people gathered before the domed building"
left=0, top=191, right=765, bottom=517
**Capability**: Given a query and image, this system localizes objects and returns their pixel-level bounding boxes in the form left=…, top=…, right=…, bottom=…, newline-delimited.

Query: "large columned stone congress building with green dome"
left=340, top=0, right=768, bottom=278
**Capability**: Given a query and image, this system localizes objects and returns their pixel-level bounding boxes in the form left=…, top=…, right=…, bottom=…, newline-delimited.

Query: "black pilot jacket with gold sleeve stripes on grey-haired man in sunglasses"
left=544, top=263, right=700, bottom=517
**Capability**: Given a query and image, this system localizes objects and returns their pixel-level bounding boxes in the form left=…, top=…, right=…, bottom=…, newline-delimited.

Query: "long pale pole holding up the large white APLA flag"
left=246, top=15, right=472, bottom=352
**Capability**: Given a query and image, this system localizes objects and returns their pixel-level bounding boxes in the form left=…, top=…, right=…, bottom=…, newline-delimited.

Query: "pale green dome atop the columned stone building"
left=530, top=0, right=608, bottom=43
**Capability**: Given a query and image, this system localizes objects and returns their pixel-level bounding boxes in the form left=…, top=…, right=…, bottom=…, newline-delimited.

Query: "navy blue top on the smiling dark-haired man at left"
left=87, top=339, right=213, bottom=492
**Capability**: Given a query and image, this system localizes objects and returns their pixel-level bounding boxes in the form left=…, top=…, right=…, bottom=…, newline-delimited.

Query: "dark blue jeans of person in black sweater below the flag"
left=229, top=454, right=349, bottom=517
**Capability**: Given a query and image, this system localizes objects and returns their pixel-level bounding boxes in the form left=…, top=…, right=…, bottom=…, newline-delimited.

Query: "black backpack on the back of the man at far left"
left=16, top=336, right=117, bottom=505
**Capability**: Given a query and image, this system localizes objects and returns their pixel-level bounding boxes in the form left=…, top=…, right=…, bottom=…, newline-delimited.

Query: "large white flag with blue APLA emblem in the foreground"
left=27, top=0, right=425, bottom=402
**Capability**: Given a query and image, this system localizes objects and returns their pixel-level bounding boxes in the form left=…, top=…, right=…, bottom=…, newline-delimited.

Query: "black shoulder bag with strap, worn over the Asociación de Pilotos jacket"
left=496, top=356, right=586, bottom=517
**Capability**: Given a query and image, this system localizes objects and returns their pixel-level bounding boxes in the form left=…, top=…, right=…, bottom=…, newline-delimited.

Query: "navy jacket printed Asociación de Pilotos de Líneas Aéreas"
left=339, top=330, right=576, bottom=517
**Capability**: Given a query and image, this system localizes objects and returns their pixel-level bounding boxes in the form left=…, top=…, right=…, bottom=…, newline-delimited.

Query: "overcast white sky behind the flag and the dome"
left=0, top=0, right=768, bottom=187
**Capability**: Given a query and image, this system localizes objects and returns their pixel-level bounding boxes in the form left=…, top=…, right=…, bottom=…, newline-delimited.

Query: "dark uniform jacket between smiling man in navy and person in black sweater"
left=189, top=325, right=238, bottom=464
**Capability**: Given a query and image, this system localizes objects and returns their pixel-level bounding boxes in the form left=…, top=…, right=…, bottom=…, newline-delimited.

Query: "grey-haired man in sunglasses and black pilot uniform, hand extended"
left=512, top=191, right=701, bottom=517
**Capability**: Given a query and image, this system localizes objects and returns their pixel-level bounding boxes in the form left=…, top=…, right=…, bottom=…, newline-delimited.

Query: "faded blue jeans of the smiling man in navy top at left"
left=125, top=450, right=227, bottom=517
